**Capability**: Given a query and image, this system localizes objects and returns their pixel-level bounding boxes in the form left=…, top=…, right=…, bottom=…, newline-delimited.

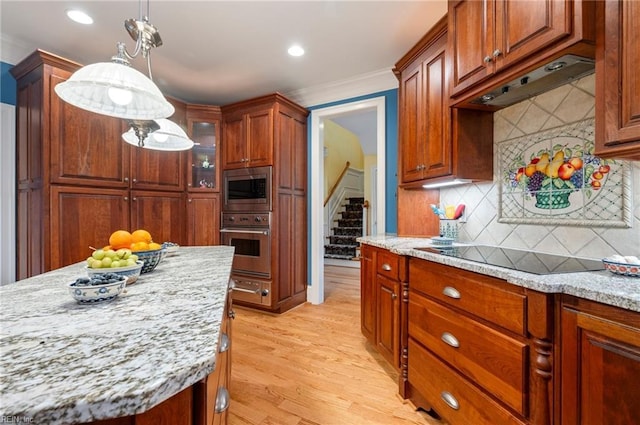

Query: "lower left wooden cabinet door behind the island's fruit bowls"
left=48, top=185, right=129, bottom=269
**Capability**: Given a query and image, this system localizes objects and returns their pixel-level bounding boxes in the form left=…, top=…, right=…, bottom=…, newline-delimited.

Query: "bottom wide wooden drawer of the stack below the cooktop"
left=408, top=338, right=524, bottom=425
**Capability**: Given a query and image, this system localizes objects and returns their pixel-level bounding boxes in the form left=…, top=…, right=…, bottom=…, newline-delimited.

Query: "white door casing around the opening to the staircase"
left=307, top=96, right=386, bottom=304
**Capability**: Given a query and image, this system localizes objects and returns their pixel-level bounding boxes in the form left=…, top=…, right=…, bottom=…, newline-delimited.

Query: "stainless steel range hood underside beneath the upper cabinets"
left=471, top=55, right=595, bottom=107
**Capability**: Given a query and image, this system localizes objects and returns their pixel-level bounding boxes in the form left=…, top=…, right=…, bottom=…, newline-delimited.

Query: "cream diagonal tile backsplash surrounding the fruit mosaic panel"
left=440, top=74, right=640, bottom=258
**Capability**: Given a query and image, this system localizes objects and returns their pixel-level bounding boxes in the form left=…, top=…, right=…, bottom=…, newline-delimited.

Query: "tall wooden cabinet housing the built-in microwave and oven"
left=222, top=93, right=309, bottom=313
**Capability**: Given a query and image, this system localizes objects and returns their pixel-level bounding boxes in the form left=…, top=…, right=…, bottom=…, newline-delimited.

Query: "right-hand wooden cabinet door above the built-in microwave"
left=245, top=108, right=273, bottom=167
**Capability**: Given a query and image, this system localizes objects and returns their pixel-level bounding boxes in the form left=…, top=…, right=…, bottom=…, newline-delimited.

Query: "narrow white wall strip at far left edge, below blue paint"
left=0, top=103, right=16, bottom=285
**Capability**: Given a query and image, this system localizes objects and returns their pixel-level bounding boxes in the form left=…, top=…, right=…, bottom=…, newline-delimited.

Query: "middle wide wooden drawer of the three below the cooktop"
left=409, top=293, right=529, bottom=416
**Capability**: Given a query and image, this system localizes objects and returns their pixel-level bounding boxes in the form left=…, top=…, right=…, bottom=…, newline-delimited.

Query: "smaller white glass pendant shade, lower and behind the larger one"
left=122, top=119, right=194, bottom=151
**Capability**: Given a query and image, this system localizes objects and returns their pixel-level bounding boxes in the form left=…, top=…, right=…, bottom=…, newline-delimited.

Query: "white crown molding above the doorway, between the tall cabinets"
left=285, top=66, right=398, bottom=108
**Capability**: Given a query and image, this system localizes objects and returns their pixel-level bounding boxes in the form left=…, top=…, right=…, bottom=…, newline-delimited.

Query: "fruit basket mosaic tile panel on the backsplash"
left=498, top=118, right=632, bottom=227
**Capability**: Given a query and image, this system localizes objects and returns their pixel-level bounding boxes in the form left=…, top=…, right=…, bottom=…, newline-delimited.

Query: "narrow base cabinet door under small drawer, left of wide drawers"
left=376, top=275, right=400, bottom=369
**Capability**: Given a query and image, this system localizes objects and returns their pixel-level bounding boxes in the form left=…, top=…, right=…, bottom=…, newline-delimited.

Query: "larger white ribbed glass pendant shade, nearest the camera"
left=55, top=58, right=175, bottom=120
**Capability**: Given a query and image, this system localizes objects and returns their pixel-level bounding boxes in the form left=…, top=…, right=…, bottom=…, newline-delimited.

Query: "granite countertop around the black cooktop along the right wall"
left=358, top=235, right=640, bottom=312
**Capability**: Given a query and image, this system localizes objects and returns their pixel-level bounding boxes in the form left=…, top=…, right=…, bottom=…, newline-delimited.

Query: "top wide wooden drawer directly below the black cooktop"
left=409, top=259, right=527, bottom=336
